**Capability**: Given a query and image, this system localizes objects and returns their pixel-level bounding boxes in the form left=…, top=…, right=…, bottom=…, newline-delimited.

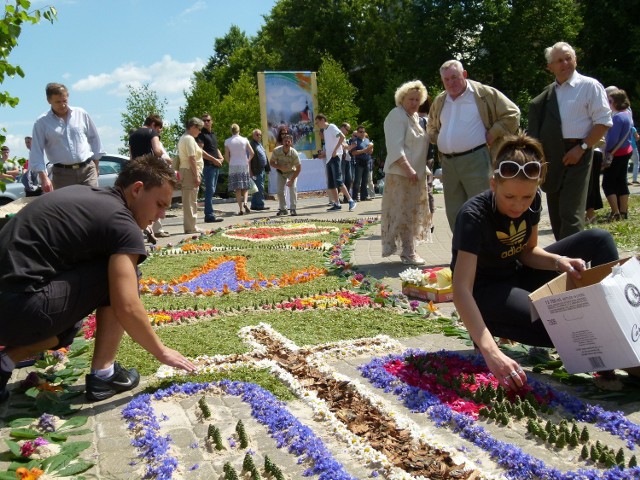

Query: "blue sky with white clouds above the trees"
left=0, top=0, right=277, bottom=157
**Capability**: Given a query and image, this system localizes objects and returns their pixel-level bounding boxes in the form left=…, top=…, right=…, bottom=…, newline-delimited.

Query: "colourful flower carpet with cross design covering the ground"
left=0, top=219, right=640, bottom=480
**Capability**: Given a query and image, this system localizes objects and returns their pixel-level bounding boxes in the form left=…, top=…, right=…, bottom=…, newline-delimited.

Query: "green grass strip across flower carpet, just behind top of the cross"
left=111, top=308, right=449, bottom=375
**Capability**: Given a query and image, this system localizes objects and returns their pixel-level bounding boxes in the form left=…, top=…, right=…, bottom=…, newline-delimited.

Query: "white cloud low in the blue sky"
left=72, top=55, right=204, bottom=97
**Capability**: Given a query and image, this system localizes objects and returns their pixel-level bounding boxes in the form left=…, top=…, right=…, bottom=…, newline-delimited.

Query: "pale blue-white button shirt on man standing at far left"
left=29, top=107, right=104, bottom=172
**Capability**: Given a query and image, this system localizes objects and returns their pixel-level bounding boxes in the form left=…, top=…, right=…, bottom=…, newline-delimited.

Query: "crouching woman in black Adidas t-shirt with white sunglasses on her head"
left=451, top=131, right=618, bottom=389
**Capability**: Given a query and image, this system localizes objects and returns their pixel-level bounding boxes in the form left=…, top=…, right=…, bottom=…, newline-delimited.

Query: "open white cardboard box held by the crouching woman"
left=529, top=257, right=640, bottom=373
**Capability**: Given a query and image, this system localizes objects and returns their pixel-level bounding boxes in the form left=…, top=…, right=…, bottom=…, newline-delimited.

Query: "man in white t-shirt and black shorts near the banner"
left=315, top=113, right=357, bottom=212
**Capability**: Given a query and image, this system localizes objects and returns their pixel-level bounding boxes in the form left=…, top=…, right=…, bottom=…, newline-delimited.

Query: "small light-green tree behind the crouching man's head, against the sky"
left=118, top=83, right=176, bottom=155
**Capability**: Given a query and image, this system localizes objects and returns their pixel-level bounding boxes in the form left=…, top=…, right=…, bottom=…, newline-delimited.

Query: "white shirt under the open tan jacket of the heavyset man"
left=438, top=82, right=487, bottom=153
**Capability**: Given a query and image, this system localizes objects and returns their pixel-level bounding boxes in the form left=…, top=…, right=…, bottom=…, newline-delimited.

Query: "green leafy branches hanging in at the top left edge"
left=0, top=0, right=57, bottom=191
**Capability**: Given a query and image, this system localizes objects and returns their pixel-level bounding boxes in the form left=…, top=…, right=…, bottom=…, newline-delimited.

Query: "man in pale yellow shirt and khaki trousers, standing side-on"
left=178, top=117, right=204, bottom=233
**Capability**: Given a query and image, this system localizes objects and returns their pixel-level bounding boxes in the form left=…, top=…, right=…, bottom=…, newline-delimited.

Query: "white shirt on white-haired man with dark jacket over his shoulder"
left=555, top=71, right=613, bottom=139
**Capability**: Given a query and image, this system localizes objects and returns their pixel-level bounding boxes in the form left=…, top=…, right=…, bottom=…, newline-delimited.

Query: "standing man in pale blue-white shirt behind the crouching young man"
left=29, top=83, right=104, bottom=192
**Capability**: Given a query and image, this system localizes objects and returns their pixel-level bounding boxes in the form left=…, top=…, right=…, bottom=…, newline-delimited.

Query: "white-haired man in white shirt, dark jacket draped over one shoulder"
left=529, top=42, right=612, bottom=240
